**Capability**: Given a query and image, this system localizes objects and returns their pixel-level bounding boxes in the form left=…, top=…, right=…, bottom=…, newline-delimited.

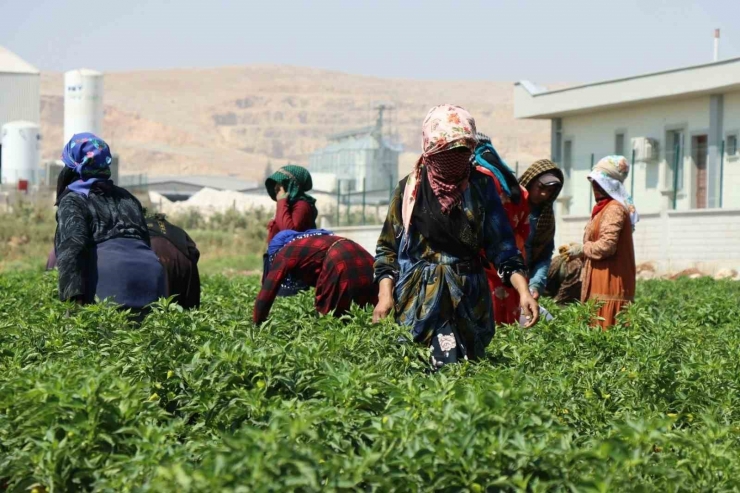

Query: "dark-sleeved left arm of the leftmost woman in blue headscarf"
left=54, top=194, right=93, bottom=301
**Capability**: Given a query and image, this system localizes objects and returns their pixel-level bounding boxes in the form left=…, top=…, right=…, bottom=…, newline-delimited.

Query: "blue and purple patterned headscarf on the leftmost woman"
left=62, top=132, right=113, bottom=197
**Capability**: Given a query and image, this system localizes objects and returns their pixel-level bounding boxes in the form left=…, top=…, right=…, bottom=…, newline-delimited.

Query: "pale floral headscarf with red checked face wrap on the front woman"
left=402, top=104, right=478, bottom=231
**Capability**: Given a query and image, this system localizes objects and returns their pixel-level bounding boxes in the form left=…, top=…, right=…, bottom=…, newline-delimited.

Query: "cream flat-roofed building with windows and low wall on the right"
left=514, top=58, right=740, bottom=271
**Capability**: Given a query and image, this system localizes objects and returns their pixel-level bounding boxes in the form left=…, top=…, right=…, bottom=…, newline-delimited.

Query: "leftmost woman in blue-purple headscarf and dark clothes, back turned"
left=54, top=133, right=165, bottom=312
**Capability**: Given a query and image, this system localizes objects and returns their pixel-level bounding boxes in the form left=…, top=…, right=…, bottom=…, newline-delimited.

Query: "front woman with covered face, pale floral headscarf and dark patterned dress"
left=373, top=105, right=539, bottom=368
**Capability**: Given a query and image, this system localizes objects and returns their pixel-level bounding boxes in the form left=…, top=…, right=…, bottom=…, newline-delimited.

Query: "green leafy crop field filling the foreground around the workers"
left=0, top=273, right=740, bottom=492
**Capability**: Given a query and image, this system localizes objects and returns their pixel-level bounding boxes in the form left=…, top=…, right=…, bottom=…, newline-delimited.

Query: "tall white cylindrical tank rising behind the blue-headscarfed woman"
left=62, top=69, right=104, bottom=145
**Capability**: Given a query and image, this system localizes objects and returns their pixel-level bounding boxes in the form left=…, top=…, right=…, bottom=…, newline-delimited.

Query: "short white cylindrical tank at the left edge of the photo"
left=0, top=121, right=41, bottom=185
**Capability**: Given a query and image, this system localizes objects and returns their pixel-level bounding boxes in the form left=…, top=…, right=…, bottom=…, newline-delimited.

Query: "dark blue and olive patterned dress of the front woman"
left=375, top=171, right=521, bottom=366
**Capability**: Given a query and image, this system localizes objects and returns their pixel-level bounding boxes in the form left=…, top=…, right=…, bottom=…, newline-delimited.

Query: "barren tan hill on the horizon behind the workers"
left=41, top=66, right=550, bottom=179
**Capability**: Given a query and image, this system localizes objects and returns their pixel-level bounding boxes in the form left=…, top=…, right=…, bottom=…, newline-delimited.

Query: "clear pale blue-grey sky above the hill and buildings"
left=0, top=0, right=740, bottom=82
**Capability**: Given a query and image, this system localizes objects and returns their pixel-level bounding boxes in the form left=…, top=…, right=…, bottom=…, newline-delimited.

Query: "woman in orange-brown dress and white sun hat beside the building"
left=566, top=156, right=639, bottom=330
